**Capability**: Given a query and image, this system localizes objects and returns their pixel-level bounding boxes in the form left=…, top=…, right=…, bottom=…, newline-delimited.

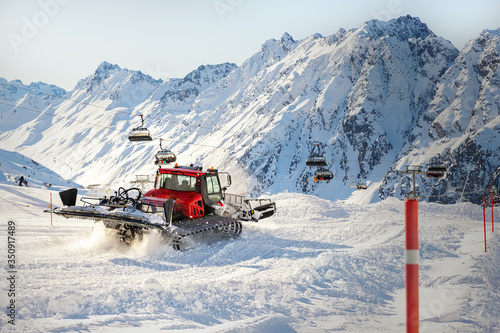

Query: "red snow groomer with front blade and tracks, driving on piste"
left=47, top=165, right=276, bottom=250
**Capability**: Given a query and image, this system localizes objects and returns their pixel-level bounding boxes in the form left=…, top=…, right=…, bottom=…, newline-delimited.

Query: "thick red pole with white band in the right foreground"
left=405, top=199, right=419, bottom=333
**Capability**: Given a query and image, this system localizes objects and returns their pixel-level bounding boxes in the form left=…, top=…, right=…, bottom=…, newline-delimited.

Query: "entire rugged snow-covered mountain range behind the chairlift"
left=0, top=16, right=500, bottom=201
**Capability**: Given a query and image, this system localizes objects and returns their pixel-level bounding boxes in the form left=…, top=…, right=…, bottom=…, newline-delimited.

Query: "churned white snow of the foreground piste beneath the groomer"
left=0, top=183, right=500, bottom=333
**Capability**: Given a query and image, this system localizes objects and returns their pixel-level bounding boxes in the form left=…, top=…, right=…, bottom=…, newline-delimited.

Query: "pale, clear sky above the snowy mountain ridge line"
left=0, top=0, right=500, bottom=90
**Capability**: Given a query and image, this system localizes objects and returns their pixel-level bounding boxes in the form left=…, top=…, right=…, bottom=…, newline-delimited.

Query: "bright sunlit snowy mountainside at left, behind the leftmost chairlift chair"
left=0, top=62, right=235, bottom=184
